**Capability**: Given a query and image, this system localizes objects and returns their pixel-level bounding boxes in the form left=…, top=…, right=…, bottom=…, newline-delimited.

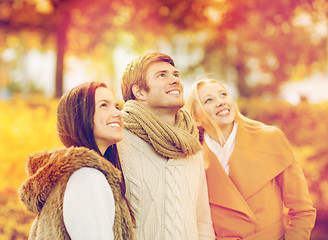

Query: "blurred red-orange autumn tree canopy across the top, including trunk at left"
left=0, top=0, right=327, bottom=97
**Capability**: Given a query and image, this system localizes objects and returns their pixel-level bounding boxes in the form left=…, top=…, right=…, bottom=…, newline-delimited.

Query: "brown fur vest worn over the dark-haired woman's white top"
left=18, top=147, right=135, bottom=240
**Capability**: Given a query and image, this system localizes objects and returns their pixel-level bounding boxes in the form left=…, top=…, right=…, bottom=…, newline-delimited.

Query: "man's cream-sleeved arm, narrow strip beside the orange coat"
left=197, top=154, right=215, bottom=239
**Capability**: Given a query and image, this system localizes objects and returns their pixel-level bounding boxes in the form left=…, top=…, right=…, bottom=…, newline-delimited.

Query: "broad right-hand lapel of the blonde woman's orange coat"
left=229, top=125, right=295, bottom=200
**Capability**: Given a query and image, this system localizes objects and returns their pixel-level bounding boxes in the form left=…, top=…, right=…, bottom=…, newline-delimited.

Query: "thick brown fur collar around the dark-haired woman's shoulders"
left=18, top=147, right=122, bottom=214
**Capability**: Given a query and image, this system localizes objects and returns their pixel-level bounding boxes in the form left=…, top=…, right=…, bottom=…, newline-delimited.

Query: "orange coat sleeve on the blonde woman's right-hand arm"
left=278, top=131, right=316, bottom=240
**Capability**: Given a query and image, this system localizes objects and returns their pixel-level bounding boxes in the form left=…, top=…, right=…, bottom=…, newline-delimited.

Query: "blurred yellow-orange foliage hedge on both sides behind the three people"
left=0, top=96, right=328, bottom=240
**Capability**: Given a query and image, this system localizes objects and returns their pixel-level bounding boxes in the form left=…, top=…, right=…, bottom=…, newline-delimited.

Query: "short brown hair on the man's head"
left=121, top=52, right=175, bottom=102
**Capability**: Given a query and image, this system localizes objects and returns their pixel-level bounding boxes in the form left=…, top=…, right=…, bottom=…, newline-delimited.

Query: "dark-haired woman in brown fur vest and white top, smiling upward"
left=18, top=82, right=135, bottom=240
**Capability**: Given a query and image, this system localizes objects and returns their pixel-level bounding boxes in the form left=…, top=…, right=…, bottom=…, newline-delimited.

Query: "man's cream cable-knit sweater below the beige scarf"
left=117, top=129, right=215, bottom=240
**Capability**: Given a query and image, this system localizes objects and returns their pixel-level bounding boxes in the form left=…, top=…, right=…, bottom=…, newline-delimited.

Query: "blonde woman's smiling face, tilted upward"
left=198, top=82, right=236, bottom=131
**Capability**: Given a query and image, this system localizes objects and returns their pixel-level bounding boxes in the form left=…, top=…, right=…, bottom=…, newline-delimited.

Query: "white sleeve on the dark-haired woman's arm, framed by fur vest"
left=63, top=167, right=115, bottom=240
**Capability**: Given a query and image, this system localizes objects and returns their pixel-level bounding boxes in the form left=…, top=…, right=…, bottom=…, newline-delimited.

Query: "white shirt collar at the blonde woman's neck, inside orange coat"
left=204, top=123, right=238, bottom=174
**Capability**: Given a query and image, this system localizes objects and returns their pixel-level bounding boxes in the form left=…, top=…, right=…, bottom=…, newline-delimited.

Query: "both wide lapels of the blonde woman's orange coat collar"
left=203, top=127, right=295, bottom=219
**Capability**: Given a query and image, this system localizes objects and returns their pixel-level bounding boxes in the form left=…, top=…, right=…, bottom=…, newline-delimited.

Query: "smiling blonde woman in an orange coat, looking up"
left=186, top=79, right=316, bottom=240
